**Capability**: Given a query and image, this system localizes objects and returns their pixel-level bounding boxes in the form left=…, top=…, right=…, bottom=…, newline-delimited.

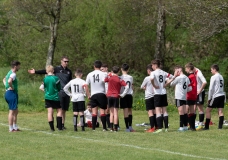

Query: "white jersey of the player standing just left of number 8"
left=141, top=76, right=154, bottom=99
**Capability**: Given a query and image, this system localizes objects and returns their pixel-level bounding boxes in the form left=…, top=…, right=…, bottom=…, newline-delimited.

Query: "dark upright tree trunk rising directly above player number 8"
left=154, top=0, right=166, bottom=66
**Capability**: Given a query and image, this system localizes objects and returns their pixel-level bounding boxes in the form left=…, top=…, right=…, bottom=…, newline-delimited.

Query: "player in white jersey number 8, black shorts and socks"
left=150, top=59, right=175, bottom=133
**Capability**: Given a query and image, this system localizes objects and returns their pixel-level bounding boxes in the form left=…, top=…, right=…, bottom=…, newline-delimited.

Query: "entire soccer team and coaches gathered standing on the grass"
left=3, top=57, right=225, bottom=133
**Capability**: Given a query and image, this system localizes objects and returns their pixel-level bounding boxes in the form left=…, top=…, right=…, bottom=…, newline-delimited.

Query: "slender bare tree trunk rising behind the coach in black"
left=46, top=0, right=62, bottom=66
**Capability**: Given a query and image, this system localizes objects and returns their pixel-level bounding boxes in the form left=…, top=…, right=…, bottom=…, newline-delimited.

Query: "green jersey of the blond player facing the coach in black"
left=43, top=75, right=61, bottom=101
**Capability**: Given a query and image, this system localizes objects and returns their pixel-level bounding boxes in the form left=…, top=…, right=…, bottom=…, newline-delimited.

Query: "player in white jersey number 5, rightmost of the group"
left=204, top=64, right=225, bottom=130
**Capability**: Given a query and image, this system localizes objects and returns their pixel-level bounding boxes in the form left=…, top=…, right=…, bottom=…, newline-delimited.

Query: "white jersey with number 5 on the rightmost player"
left=208, top=73, right=225, bottom=100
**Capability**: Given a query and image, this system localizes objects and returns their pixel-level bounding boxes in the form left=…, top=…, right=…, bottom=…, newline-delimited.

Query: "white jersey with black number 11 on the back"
left=63, top=78, right=87, bottom=102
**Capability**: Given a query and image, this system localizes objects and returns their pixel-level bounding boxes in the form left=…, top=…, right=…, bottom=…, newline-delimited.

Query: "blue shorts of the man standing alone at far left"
left=5, top=90, right=18, bottom=110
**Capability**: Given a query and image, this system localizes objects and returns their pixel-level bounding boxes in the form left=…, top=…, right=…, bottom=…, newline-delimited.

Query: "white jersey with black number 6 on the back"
left=170, top=74, right=191, bottom=100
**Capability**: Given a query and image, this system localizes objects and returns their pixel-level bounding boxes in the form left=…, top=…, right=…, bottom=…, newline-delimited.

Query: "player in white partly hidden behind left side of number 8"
left=141, top=64, right=157, bottom=132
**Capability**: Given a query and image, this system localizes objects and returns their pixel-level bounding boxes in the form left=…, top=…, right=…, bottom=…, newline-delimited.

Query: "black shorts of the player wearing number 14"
left=90, top=93, right=107, bottom=109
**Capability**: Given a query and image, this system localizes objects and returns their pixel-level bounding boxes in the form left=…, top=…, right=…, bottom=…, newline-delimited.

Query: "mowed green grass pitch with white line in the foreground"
left=0, top=111, right=228, bottom=160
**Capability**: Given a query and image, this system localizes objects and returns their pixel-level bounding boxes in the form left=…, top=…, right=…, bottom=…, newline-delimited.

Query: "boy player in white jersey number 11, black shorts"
left=63, top=69, right=88, bottom=131
